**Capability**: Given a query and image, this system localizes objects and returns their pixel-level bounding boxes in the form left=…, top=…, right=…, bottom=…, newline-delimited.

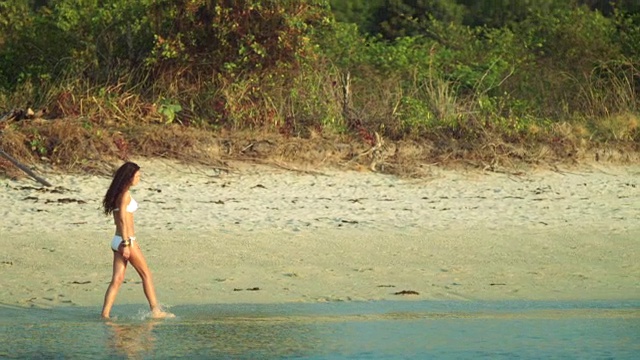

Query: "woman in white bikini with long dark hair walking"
left=102, top=162, right=174, bottom=319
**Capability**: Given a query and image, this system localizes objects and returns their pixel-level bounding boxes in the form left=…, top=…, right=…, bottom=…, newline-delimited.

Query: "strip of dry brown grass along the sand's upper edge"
left=0, top=117, right=640, bottom=181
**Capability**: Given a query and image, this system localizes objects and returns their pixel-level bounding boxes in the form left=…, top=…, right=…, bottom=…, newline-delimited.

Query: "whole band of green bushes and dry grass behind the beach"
left=0, top=0, right=640, bottom=172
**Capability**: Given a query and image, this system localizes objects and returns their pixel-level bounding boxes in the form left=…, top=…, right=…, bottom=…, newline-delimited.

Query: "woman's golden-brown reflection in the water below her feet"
left=106, top=320, right=158, bottom=359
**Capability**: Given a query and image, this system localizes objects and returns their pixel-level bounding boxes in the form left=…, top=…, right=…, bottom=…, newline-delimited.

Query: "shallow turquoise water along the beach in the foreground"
left=0, top=301, right=640, bottom=359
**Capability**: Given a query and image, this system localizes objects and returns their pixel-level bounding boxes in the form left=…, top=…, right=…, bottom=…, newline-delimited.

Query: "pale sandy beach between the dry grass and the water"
left=0, top=159, right=640, bottom=309
